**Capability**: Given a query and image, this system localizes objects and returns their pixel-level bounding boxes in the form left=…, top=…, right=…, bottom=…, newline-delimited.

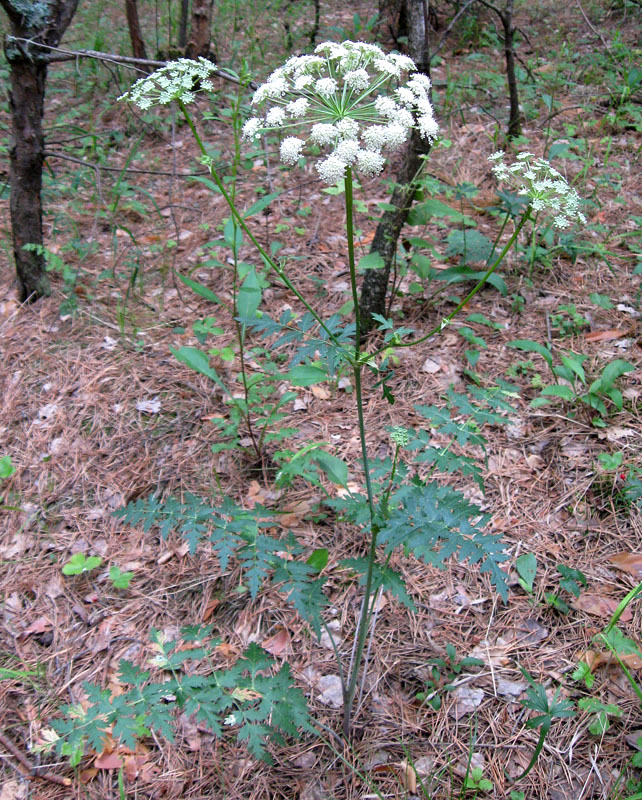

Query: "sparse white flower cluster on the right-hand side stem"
left=488, top=150, right=586, bottom=229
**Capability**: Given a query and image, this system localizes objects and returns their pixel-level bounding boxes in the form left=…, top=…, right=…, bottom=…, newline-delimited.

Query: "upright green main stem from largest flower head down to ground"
left=343, top=167, right=379, bottom=739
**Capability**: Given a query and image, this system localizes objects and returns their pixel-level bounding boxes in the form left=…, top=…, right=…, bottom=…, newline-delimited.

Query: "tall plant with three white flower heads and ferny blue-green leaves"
left=112, top=50, right=582, bottom=756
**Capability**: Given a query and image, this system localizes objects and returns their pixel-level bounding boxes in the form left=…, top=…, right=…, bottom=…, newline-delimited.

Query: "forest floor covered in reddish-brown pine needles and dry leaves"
left=0, top=3, right=642, bottom=800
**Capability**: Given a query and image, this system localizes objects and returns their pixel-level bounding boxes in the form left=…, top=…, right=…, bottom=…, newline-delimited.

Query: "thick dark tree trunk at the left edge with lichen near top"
left=0, top=0, right=78, bottom=302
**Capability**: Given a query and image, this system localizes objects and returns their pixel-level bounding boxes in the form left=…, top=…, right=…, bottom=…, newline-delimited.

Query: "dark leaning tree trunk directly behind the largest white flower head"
left=359, top=0, right=431, bottom=332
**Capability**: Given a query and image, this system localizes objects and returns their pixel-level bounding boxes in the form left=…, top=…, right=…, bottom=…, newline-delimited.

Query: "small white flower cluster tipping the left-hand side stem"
left=118, top=58, right=216, bottom=109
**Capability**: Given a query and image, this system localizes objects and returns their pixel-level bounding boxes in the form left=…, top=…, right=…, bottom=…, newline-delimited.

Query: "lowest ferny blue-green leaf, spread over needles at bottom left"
left=52, top=628, right=310, bottom=766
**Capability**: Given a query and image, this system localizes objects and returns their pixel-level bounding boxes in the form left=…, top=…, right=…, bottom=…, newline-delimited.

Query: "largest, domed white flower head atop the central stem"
left=243, top=42, right=439, bottom=184
